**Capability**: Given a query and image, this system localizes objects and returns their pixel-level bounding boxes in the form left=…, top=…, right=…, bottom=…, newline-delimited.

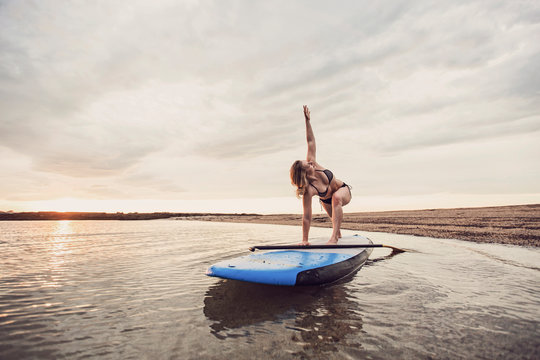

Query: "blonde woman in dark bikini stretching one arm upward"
left=291, top=105, right=352, bottom=245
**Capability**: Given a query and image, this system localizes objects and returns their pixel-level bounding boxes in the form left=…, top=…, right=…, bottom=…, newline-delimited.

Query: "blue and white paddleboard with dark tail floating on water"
left=206, top=235, right=373, bottom=286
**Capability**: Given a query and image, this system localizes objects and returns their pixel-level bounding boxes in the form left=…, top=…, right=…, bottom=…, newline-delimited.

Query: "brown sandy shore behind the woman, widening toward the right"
left=179, top=204, right=540, bottom=247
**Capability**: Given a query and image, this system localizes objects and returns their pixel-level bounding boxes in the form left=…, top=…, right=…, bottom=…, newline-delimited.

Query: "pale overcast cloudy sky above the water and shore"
left=0, top=0, right=540, bottom=213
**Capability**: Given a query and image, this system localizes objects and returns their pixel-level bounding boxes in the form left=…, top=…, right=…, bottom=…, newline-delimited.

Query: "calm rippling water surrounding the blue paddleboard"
left=0, top=220, right=540, bottom=359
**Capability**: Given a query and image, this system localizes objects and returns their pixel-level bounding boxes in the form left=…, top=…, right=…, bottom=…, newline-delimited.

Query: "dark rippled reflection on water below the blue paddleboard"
left=204, top=280, right=368, bottom=355
